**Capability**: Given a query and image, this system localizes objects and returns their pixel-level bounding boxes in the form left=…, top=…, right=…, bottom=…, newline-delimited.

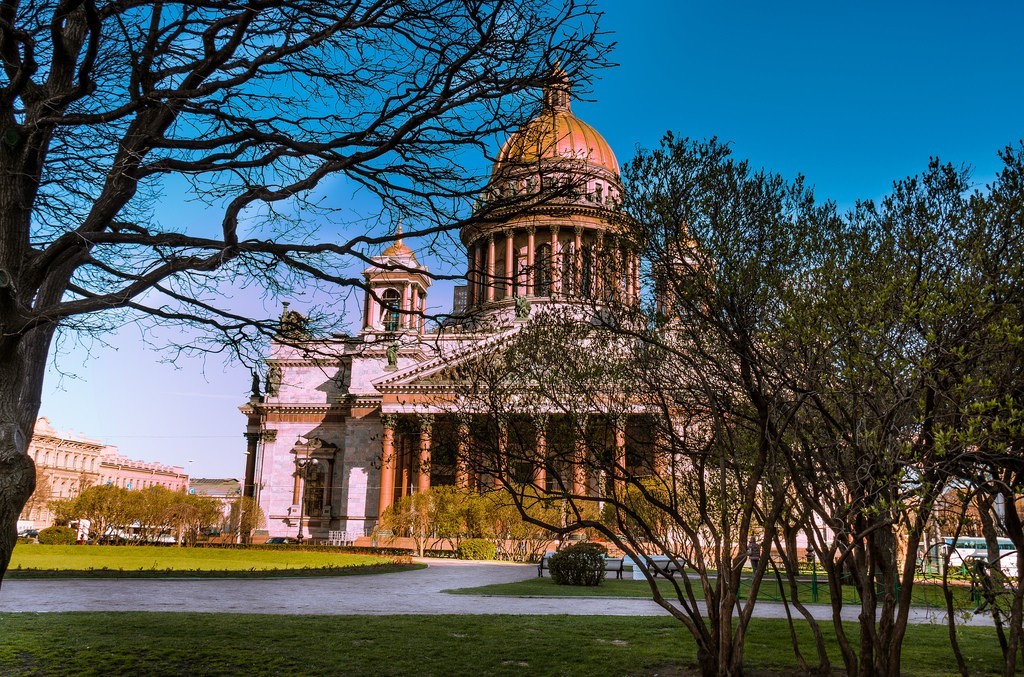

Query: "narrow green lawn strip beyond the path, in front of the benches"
left=449, top=578, right=973, bottom=608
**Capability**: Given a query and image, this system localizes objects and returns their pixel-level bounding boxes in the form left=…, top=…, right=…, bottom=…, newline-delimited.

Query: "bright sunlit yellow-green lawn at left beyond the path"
left=7, top=544, right=420, bottom=578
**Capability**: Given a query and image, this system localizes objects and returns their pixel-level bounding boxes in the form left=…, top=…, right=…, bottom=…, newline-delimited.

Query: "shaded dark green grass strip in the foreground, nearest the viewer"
left=0, top=612, right=999, bottom=677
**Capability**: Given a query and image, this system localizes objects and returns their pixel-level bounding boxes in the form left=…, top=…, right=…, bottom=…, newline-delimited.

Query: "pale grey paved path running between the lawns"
left=0, top=560, right=991, bottom=625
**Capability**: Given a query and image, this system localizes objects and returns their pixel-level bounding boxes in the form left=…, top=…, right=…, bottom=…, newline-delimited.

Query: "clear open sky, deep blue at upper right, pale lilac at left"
left=41, top=0, right=1024, bottom=477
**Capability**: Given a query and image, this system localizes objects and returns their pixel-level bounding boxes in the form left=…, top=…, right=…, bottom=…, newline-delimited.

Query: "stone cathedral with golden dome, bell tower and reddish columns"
left=242, top=73, right=643, bottom=541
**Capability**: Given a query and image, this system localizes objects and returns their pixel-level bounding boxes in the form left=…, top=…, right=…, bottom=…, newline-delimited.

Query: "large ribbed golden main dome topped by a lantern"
left=494, top=73, right=618, bottom=178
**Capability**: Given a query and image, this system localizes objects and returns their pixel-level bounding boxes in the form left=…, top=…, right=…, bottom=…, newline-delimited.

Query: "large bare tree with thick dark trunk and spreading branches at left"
left=0, top=0, right=606, bottom=575
